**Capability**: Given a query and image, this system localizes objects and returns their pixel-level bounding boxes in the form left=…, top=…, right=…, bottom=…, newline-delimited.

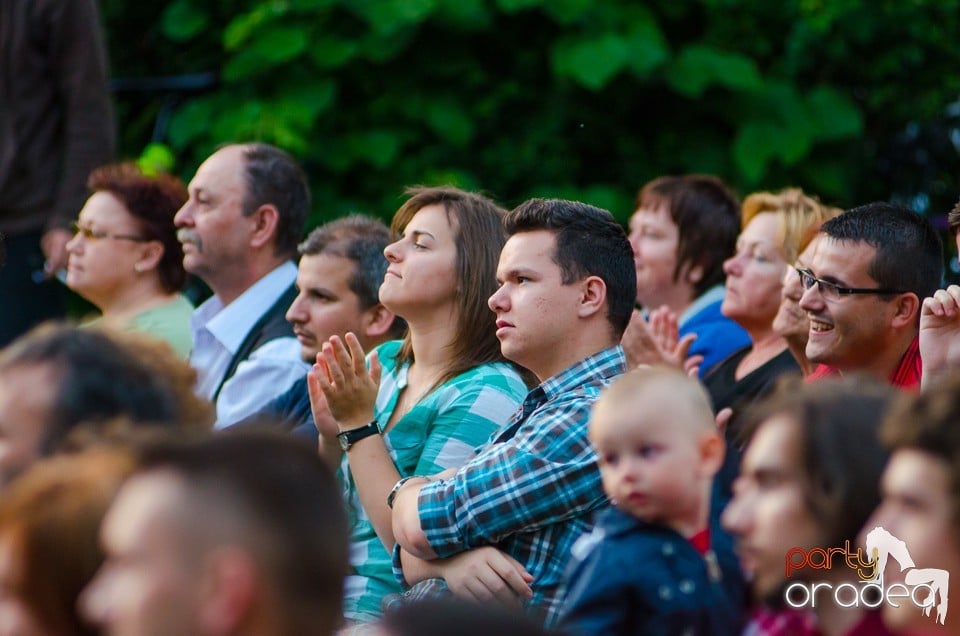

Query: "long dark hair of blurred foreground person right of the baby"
left=744, top=374, right=897, bottom=546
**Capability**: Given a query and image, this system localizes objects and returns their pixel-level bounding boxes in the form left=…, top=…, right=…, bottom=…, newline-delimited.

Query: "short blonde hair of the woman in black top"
left=740, top=188, right=843, bottom=263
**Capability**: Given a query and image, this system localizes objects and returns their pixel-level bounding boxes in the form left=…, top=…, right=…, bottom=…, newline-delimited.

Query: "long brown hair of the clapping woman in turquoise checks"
left=390, top=186, right=507, bottom=390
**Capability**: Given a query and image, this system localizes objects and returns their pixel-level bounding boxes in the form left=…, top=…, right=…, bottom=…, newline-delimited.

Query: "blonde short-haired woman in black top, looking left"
left=703, top=188, right=832, bottom=501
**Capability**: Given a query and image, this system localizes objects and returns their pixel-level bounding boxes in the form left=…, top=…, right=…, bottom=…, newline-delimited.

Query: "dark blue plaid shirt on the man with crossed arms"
left=394, top=345, right=626, bottom=625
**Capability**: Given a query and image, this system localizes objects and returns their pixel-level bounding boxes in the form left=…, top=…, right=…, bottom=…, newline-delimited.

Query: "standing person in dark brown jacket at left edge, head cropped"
left=0, top=0, right=114, bottom=346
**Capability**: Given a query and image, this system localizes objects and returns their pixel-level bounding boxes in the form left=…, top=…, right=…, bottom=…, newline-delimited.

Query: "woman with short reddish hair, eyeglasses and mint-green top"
left=67, top=163, right=193, bottom=357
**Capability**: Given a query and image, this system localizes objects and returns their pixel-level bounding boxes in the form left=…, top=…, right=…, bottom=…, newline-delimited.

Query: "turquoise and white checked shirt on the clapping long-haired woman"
left=338, top=341, right=526, bottom=622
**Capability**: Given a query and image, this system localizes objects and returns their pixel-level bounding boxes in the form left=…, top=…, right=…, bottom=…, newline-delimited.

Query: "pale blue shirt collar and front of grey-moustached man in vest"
left=190, top=261, right=297, bottom=353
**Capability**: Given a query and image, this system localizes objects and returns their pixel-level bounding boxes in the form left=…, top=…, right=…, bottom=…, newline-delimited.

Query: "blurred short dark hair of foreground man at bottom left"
left=138, top=431, right=349, bottom=634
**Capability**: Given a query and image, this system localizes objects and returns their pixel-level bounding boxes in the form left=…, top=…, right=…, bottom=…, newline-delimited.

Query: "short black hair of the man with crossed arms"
left=504, top=199, right=637, bottom=340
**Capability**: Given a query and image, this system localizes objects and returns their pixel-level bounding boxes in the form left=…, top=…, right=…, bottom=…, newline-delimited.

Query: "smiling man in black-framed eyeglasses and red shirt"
left=799, top=203, right=943, bottom=389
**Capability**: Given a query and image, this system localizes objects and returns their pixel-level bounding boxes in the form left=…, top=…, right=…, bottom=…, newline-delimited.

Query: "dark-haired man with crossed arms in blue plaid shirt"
left=391, top=199, right=636, bottom=625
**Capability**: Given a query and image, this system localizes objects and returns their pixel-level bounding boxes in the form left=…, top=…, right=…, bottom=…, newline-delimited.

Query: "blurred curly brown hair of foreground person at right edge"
left=880, top=375, right=960, bottom=528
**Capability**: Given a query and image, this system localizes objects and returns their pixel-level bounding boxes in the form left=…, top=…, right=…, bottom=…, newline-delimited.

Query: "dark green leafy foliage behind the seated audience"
left=101, top=0, right=960, bottom=238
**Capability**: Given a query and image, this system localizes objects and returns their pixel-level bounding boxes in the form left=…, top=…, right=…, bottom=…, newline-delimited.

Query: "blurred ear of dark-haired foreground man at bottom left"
left=197, top=546, right=263, bottom=635
